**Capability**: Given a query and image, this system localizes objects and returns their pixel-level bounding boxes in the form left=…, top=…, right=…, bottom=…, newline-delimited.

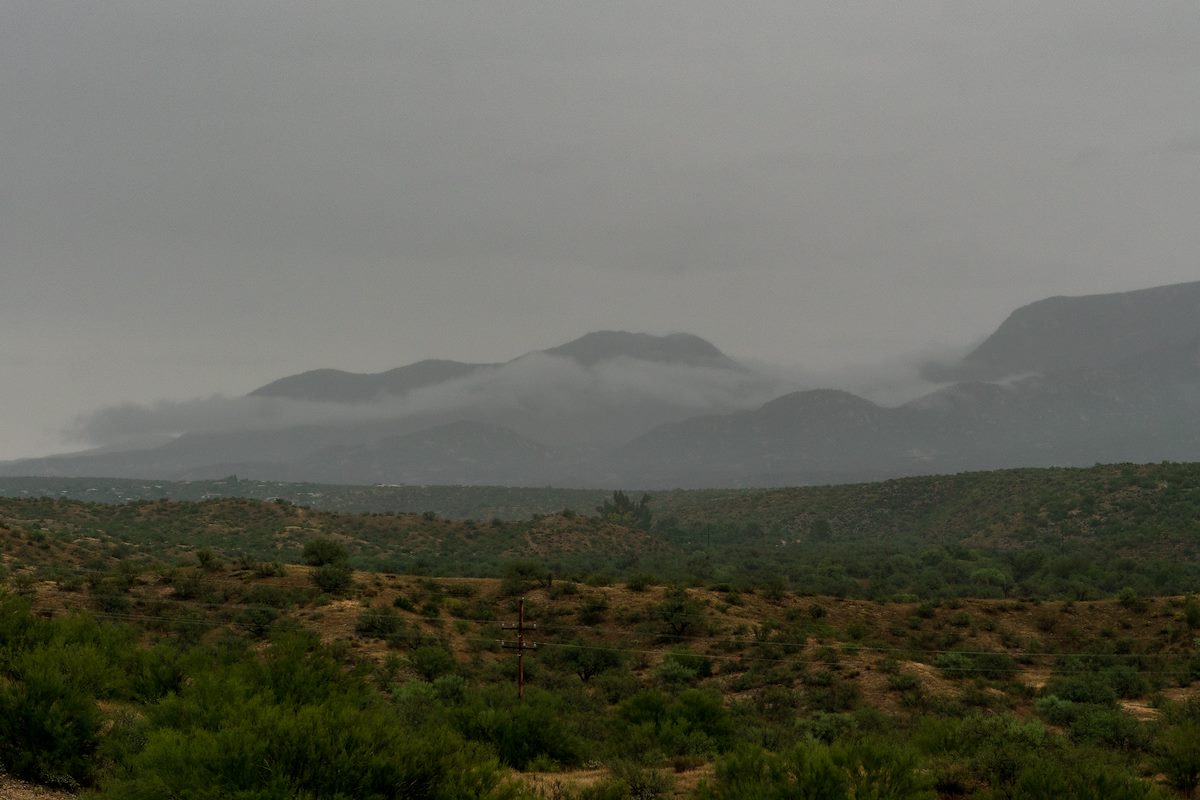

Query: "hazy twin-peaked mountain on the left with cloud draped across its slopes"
left=0, top=331, right=778, bottom=485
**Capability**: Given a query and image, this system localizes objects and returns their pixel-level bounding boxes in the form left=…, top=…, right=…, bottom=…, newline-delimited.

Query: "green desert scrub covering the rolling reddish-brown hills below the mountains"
left=0, top=465, right=1200, bottom=800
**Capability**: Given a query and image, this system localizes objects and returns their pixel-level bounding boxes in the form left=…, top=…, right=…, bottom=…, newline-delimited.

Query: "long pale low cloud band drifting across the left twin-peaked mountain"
left=67, top=354, right=794, bottom=446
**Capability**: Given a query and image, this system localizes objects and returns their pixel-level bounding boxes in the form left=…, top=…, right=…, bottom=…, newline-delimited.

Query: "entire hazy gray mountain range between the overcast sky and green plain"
left=7, top=283, right=1200, bottom=488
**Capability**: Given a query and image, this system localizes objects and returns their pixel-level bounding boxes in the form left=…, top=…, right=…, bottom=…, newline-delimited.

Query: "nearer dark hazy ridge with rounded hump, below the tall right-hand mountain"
left=608, top=335, right=1200, bottom=488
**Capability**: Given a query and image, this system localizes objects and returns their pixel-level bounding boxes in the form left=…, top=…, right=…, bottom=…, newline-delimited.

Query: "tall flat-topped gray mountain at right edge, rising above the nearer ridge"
left=932, top=282, right=1200, bottom=380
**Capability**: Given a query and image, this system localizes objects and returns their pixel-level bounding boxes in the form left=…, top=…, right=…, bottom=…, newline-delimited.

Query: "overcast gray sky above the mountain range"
left=0, top=0, right=1200, bottom=458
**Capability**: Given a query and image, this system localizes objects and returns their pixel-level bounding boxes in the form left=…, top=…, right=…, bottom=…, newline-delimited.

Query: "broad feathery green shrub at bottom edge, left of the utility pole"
left=97, top=685, right=511, bottom=800
